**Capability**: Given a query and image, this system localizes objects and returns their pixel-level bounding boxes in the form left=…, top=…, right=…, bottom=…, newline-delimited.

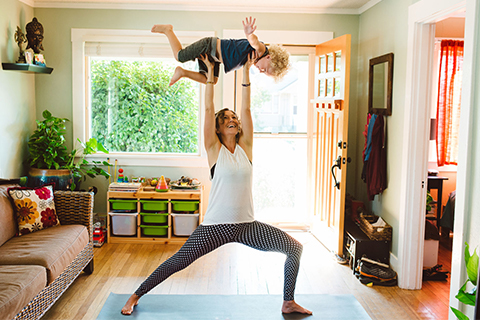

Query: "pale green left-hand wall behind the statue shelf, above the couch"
left=0, top=0, right=36, bottom=178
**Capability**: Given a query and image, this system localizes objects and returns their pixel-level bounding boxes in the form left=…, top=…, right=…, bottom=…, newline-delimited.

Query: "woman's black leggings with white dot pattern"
left=135, top=221, right=303, bottom=301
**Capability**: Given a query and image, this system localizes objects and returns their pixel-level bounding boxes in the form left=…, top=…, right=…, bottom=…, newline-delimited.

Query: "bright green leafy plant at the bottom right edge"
left=450, top=243, right=478, bottom=320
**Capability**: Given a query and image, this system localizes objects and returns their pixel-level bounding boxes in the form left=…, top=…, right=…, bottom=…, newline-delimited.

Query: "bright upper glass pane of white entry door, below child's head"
left=250, top=55, right=308, bottom=133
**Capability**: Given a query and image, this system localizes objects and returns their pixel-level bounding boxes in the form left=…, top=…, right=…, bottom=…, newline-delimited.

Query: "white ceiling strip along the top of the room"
left=20, top=0, right=381, bottom=14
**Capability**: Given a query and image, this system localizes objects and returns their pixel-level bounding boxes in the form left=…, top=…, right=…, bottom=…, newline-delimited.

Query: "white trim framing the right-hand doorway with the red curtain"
left=399, top=0, right=480, bottom=317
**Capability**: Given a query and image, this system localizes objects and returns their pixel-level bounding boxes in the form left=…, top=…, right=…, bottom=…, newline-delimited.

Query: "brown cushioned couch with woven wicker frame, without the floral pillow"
left=0, top=185, right=93, bottom=319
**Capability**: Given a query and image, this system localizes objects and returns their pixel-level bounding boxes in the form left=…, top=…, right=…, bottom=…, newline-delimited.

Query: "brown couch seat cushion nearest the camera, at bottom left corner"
left=0, top=266, right=47, bottom=319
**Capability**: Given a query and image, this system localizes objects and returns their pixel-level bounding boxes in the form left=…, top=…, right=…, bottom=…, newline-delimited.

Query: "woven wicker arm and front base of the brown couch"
left=14, top=191, right=93, bottom=320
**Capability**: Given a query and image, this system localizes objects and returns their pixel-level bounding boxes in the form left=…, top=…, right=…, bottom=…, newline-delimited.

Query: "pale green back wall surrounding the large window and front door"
left=35, top=9, right=358, bottom=212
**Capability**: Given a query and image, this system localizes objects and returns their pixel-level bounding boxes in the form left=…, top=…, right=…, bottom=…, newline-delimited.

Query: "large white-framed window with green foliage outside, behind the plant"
left=72, top=29, right=212, bottom=167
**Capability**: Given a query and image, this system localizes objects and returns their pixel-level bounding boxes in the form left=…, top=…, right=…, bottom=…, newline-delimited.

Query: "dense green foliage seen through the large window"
left=90, top=59, right=199, bottom=153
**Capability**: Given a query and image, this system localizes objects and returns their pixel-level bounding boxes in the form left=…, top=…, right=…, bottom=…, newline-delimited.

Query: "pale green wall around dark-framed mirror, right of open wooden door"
left=355, top=0, right=412, bottom=256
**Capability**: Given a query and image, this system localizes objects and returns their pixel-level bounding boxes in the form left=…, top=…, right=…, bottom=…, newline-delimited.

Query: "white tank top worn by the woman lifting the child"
left=202, top=144, right=254, bottom=225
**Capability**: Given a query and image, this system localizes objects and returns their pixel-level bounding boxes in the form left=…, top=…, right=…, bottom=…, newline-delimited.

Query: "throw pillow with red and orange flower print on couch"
left=8, top=183, right=60, bottom=236
